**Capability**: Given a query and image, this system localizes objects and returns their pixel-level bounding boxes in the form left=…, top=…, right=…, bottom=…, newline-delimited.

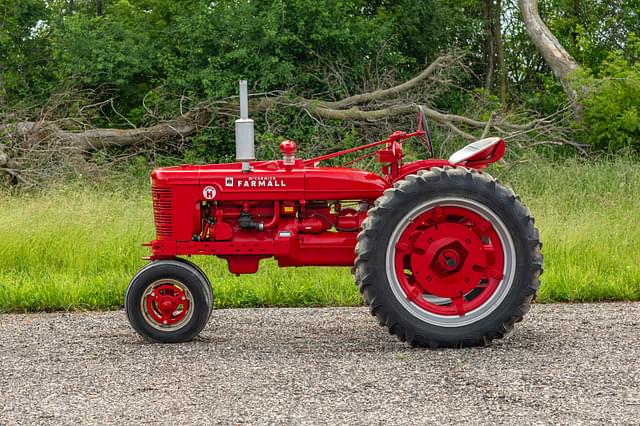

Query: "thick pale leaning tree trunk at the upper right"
left=518, top=0, right=580, bottom=108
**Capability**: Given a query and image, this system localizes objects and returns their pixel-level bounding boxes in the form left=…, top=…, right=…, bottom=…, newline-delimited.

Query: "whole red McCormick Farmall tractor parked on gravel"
left=125, top=81, right=542, bottom=348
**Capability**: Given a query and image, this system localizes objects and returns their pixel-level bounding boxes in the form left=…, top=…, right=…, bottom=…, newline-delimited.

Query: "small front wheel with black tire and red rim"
left=125, top=259, right=213, bottom=343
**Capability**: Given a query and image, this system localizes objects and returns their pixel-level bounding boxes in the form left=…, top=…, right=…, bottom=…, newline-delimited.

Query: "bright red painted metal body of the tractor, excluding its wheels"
left=149, top=130, right=499, bottom=274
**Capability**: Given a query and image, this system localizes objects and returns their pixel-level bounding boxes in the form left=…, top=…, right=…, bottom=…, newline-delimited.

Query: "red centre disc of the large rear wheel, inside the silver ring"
left=395, top=206, right=504, bottom=316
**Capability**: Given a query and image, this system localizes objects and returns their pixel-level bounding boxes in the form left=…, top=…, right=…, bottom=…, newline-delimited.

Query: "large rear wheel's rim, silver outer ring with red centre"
left=386, top=197, right=516, bottom=327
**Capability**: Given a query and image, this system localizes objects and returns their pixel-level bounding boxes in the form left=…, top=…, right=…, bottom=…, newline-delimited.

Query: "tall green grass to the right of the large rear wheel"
left=500, top=159, right=640, bottom=302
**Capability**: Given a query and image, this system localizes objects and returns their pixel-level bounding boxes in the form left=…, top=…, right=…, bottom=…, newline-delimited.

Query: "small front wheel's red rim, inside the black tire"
left=140, top=279, right=195, bottom=332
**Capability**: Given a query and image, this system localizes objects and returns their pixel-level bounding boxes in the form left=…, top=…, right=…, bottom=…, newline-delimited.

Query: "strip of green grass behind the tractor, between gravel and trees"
left=0, top=159, right=640, bottom=312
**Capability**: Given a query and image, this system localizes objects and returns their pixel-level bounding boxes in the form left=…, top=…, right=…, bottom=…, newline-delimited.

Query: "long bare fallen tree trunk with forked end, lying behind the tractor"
left=0, top=54, right=537, bottom=151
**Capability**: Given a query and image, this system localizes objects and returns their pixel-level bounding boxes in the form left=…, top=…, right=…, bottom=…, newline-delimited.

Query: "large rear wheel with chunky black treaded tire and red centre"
left=355, top=167, right=542, bottom=347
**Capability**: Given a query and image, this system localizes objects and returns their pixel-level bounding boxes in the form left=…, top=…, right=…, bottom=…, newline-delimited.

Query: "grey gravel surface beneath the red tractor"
left=0, top=303, right=640, bottom=426
